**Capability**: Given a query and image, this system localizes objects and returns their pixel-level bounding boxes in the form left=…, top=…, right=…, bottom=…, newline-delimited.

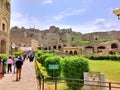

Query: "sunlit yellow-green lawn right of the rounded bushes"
left=89, top=60, right=120, bottom=82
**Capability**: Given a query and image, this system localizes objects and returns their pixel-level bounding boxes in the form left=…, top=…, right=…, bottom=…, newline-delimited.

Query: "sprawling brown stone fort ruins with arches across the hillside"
left=10, top=26, right=120, bottom=56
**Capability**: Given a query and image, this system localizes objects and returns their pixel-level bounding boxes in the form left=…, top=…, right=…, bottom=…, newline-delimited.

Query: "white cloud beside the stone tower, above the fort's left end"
left=11, top=12, right=41, bottom=28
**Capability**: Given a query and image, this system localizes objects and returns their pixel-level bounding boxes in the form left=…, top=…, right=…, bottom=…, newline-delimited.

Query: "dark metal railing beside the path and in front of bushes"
left=36, top=60, right=120, bottom=90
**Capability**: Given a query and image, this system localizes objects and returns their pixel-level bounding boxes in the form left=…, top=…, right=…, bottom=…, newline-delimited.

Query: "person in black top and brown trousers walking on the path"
left=15, top=57, right=23, bottom=81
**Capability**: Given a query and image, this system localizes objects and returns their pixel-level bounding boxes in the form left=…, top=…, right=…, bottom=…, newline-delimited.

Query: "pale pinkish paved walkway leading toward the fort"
left=0, top=62, right=38, bottom=90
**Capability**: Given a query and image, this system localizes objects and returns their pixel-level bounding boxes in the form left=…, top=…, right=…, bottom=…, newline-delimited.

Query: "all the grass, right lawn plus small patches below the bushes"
left=46, top=60, right=120, bottom=90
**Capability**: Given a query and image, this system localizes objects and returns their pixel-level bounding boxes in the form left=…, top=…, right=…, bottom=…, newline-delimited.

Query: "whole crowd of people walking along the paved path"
left=0, top=52, right=35, bottom=81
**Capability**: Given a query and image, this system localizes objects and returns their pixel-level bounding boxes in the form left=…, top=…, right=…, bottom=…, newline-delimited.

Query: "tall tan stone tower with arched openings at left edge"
left=0, top=0, right=10, bottom=54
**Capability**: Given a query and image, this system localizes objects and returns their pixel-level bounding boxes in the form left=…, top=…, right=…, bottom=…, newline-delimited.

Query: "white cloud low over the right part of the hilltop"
left=58, top=19, right=120, bottom=34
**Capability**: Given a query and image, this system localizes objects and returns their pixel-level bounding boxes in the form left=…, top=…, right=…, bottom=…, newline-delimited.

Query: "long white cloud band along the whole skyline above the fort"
left=11, top=12, right=120, bottom=33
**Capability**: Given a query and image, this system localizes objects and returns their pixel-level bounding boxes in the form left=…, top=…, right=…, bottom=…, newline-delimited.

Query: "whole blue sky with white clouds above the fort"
left=11, top=0, right=120, bottom=33
